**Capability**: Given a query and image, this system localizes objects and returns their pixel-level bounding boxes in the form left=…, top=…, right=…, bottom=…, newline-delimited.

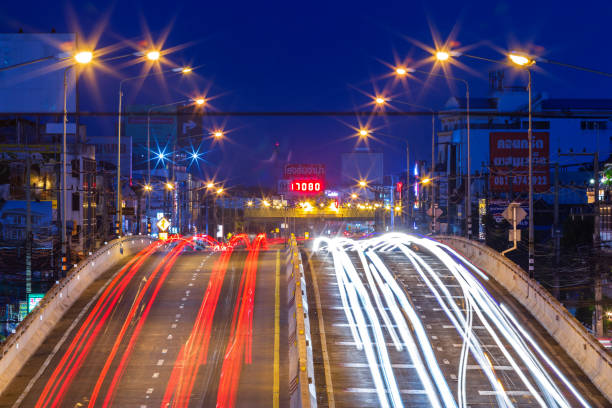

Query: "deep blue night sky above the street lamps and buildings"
left=0, top=0, right=612, bottom=184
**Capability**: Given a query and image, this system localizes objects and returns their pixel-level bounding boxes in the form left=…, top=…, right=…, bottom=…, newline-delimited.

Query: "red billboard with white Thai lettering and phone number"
left=489, top=132, right=550, bottom=193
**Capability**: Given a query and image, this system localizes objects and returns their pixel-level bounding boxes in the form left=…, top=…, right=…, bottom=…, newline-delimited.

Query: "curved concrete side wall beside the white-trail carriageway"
left=436, top=236, right=612, bottom=402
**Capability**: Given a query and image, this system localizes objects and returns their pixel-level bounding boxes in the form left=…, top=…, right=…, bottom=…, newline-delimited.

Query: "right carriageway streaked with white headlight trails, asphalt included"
left=307, top=237, right=608, bottom=407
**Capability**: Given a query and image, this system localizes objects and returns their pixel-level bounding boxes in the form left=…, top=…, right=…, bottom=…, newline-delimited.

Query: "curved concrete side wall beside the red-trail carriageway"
left=0, top=236, right=154, bottom=393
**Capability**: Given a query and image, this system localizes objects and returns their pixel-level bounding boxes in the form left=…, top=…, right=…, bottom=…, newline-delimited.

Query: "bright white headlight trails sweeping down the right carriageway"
left=313, top=233, right=589, bottom=408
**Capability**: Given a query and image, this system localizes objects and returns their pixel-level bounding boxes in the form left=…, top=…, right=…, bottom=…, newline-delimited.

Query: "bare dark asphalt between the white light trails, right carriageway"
left=303, top=236, right=610, bottom=407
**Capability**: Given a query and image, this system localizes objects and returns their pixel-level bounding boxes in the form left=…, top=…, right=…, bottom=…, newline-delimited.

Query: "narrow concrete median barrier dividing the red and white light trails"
left=286, top=234, right=317, bottom=408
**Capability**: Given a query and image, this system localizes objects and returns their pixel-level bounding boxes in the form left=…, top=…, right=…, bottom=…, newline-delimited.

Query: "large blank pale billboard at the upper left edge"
left=0, top=33, right=76, bottom=113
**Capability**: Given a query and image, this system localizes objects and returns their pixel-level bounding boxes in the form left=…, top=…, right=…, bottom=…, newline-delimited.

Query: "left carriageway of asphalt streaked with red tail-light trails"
left=0, top=241, right=288, bottom=408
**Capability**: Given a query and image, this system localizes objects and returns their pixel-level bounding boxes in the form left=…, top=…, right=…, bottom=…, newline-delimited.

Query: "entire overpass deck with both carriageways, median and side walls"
left=0, top=234, right=612, bottom=408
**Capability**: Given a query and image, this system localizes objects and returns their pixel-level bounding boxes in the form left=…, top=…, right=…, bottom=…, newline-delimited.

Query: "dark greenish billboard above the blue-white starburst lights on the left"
left=122, top=105, right=177, bottom=170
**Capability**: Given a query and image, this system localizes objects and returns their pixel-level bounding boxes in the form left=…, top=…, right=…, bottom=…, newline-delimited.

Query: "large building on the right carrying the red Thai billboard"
left=436, top=71, right=612, bottom=232
